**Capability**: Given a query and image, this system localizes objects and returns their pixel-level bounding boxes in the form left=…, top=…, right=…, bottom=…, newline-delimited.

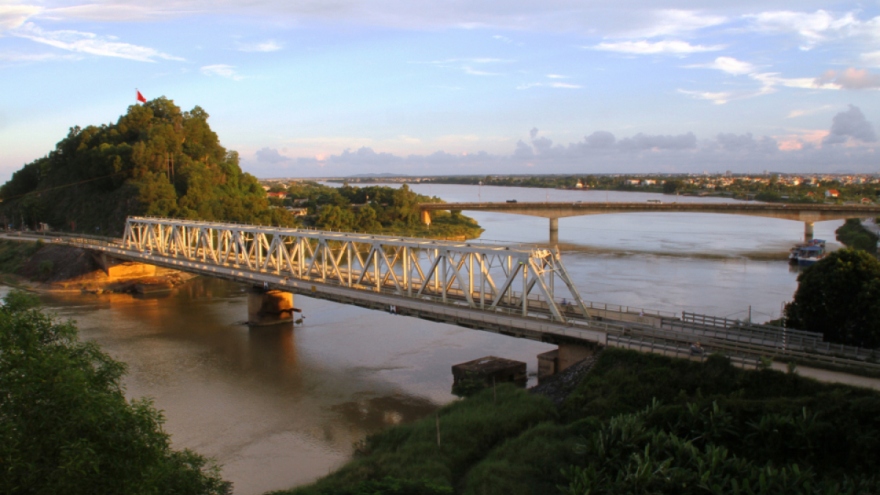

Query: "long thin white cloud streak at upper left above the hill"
left=8, top=22, right=183, bottom=62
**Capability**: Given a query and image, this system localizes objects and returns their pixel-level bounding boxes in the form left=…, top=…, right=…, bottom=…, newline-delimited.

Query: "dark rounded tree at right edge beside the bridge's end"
left=785, top=249, right=880, bottom=348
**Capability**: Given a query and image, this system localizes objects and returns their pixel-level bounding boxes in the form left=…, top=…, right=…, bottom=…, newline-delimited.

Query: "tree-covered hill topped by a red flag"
left=0, top=98, right=292, bottom=234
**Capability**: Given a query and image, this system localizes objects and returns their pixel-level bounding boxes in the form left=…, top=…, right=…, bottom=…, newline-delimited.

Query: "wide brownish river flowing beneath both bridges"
left=0, top=184, right=842, bottom=495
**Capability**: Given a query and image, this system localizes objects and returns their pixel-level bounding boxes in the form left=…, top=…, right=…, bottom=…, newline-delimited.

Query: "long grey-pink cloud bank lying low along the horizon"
left=245, top=125, right=878, bottom=177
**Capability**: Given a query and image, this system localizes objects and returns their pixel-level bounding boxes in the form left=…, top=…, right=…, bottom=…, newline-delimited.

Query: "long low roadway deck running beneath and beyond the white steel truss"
left=12, top=219, right=880, bottom=378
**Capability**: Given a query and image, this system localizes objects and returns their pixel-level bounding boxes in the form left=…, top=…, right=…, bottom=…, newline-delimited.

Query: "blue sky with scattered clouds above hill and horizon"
left=0, top=0, right=880, bottom=182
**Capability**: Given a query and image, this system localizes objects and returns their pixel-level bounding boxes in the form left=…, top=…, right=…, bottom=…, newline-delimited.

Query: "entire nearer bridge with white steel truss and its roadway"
left=10, top=217, right=880, bottom=372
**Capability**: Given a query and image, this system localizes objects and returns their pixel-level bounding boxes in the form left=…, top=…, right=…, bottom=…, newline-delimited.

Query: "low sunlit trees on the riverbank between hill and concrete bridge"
left=287, top=182, right=483, bottom=238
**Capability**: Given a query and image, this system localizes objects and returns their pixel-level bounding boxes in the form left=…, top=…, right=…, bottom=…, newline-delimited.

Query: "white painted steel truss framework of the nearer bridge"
left=123, top=217, right=589, bottom=323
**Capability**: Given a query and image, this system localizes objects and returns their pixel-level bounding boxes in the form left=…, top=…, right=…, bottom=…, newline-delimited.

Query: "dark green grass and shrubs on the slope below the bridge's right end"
left=276, top=349, right=880, bottom=495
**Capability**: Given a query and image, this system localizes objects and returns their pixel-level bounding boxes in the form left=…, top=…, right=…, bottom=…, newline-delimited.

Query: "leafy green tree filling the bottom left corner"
left=0, top=292, right=229, bottom=495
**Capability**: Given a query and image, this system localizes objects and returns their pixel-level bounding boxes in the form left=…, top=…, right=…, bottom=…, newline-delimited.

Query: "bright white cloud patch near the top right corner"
left=747, top=10, right=861, bottom=50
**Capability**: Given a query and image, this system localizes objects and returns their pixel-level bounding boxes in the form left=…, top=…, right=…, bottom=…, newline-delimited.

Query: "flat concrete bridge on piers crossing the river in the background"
left=419, top=200, right=880, bottom=244
